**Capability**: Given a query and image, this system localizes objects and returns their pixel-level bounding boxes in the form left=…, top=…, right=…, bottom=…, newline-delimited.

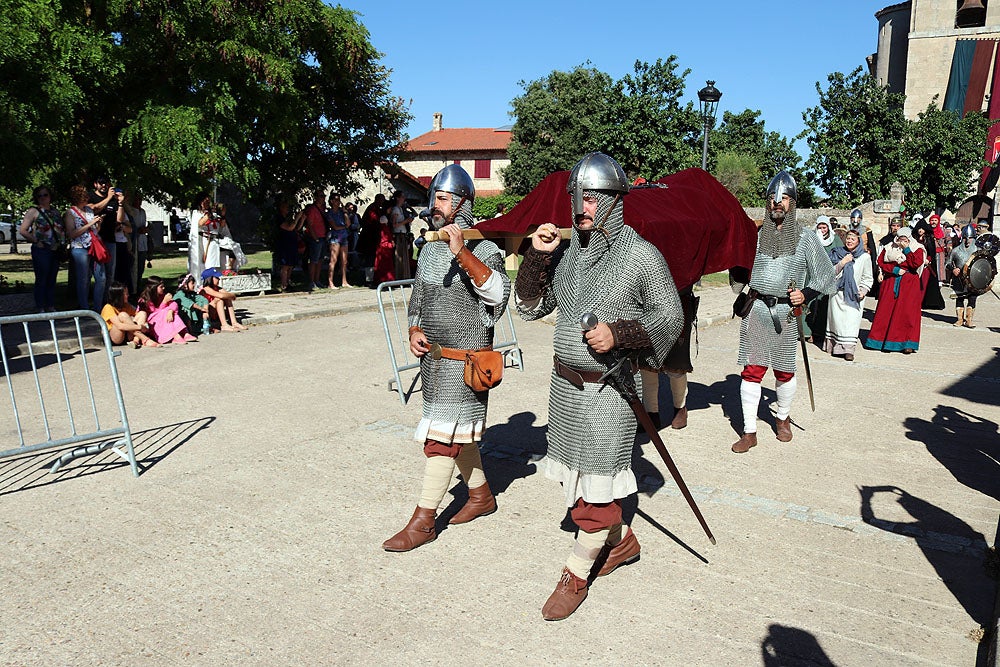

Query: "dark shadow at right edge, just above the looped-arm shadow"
left=903, top=405, right=1000, bottom=500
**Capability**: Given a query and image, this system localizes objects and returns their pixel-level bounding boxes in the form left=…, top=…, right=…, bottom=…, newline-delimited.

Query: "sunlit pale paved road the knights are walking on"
left=0, top=288, right=1000, bottom=666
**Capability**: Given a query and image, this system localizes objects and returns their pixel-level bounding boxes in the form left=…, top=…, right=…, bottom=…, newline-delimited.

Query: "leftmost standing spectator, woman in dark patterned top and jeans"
left=18, top=185, right=64, bottom=313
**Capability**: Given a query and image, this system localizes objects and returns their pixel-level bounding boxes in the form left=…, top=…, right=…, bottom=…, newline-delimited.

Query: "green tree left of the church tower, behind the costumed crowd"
left=799, top=67, right=907, bottom=206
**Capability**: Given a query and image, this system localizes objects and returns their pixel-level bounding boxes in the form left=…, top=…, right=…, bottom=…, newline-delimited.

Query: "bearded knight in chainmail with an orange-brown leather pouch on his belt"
left=382, top=165, right=510, bottom=551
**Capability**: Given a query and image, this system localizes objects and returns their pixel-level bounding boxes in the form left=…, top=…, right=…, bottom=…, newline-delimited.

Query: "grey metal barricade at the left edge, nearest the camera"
left=0, top=310, right=139, bottom=477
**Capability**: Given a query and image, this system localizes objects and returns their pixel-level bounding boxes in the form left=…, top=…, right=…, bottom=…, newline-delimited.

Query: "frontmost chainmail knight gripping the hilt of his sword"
left=514, top=153, right=683, bottom=620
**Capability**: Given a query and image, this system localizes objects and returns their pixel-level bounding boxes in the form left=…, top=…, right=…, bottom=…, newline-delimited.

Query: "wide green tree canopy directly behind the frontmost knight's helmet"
left=504, top=56, right=701, bottom=195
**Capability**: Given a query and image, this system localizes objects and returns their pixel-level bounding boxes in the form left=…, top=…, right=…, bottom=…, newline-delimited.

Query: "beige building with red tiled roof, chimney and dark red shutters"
left=399, top=113, right=510, bottom=197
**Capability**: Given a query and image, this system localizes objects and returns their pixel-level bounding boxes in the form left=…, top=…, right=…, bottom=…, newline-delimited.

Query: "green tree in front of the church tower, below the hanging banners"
left=900, top=102, right=991, bottom=211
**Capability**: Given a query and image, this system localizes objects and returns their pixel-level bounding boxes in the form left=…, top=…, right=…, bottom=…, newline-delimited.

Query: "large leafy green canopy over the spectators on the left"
left=0, top=0, right=409, bottom=206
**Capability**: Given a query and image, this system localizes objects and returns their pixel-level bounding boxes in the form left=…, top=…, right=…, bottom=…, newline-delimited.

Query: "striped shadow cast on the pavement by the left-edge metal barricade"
left=0, top=417, right=215, bottom=496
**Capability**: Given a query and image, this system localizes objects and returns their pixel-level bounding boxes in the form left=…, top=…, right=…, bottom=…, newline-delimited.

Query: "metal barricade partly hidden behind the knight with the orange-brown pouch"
left=377, top=279, right=524, bottom=405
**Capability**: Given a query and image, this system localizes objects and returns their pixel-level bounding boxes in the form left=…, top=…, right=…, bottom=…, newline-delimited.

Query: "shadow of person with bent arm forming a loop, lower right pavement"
left=858, top=486, right=994, bottom=653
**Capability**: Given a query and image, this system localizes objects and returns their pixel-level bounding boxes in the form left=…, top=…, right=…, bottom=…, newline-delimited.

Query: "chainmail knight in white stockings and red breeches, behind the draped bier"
left=732, top=171, right=837, bottom=454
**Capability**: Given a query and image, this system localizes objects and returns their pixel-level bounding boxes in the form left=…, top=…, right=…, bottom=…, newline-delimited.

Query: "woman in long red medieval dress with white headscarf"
left=865, top=227, right=930, bottom=354
